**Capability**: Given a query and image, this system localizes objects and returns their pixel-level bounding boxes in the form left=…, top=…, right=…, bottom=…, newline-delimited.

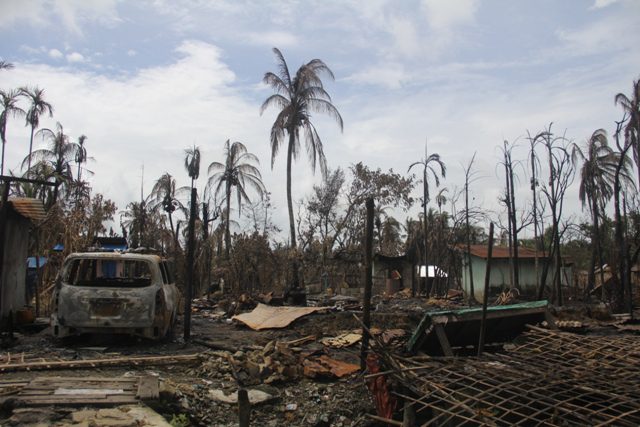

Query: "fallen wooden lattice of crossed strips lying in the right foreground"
left=387, top=328, right=640, bottom=426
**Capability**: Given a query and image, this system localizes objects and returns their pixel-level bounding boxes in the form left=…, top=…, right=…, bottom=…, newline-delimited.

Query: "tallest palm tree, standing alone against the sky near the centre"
left=260, top=48, right=343, bottom=256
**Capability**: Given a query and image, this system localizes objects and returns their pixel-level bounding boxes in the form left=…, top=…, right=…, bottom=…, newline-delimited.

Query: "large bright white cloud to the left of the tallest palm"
left=3, top=41, right=284, bottom=226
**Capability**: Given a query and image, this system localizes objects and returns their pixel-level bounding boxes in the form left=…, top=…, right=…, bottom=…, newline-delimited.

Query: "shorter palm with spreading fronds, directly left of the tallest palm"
left=208, top=139, right=266, bottom=259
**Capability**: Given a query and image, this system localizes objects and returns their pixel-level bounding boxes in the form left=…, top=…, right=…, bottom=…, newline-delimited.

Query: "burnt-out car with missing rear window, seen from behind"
left=51, top=252, right=180, bottom=339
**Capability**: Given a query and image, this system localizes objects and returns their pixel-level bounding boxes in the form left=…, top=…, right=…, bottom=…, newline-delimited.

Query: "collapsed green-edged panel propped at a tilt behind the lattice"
left=407, top=300, right=549, bottom=355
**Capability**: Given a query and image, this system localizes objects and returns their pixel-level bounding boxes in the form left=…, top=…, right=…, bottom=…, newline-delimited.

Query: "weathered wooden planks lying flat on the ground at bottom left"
left=16, top=377, right=139, bottom=406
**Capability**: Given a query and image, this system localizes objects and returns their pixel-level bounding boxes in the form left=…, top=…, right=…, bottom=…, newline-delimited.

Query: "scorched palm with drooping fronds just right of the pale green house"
left=573, top=129, right=632, bottom=296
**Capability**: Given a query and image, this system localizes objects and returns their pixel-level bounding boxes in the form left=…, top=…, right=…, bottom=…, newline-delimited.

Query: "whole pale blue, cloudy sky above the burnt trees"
left=0, top=0, right=640, bottom=239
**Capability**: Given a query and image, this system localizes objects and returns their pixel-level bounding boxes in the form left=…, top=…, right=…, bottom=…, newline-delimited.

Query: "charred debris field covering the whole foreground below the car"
left=0, top=290, right=640, bottom=426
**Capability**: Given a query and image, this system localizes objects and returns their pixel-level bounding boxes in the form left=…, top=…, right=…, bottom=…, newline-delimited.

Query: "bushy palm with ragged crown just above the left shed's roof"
left=22, top=123, right=79, bottom=203
